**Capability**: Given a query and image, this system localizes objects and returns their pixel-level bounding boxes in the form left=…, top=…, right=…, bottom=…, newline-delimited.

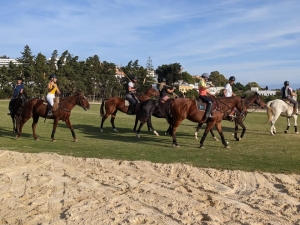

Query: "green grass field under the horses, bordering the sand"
left=0, top=101, right=300, bottom=174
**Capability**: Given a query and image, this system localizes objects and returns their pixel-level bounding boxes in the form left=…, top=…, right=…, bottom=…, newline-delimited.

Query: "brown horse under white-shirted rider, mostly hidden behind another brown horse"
left=195, top=92, right=266, bottom=141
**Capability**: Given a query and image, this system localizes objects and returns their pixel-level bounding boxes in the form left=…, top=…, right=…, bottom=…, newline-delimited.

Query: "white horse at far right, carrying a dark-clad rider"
left=267, top=99, right=298, bottom=135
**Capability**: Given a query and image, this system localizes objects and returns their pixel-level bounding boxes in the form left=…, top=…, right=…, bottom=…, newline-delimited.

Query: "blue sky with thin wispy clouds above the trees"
left=0, top=0, right=300, bottom=89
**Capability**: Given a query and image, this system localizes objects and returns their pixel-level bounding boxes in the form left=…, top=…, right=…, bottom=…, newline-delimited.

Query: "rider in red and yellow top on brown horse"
left=199, top=73, right=215, bottom=119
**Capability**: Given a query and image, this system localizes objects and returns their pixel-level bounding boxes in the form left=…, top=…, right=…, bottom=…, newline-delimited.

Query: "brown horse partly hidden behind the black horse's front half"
left=100, top=86, right=159, bottom=132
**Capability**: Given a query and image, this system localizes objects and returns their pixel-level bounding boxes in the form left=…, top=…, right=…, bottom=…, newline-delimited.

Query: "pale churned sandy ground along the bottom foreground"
left=0, top=151, right=300, bottom=225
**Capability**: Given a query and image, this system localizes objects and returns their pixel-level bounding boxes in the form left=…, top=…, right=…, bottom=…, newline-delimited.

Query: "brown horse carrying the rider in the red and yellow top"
left=167, top=96, right=244, bottom=148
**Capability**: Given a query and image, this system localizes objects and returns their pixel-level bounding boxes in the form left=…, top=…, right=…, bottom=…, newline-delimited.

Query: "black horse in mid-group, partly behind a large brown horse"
left=133, top=98, right=173, bottom=138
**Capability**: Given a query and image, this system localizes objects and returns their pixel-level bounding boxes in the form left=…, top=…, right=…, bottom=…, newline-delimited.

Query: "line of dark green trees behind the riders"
left=0, top=45, right=290, bottom=102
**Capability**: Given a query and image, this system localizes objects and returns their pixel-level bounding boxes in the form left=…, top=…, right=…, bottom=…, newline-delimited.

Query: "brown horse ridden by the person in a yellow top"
left=17, top=92, right=90, bottom=142
